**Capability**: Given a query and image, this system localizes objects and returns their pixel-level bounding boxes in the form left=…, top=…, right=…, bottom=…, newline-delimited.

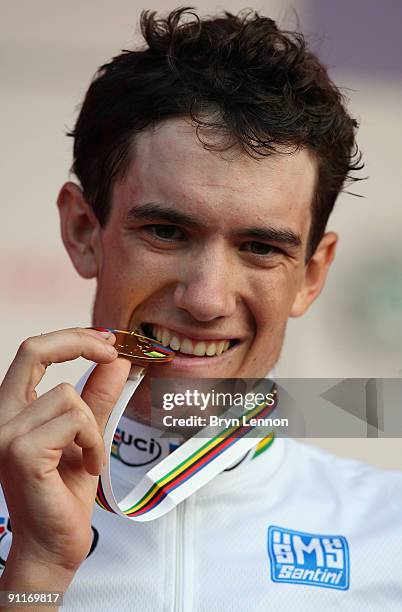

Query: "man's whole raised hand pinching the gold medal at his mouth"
left=0, top=329, right=131, bottom=572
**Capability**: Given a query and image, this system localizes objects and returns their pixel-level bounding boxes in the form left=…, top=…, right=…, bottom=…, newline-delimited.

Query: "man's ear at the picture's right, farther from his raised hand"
left=290, top=232, right=338, bottom=317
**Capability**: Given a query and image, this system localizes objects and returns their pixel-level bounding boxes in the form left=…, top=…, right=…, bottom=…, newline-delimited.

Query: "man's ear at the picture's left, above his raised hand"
left=57, top=181, right=102, bottom=278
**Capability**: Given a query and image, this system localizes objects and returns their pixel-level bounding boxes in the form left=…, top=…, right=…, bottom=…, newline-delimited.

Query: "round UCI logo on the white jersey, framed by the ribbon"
left=112, top=428, right=162, bottom=467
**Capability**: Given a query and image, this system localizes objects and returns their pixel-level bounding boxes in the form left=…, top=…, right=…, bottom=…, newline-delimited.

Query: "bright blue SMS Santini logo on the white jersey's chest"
left=268, top=525, right=349, bottom=591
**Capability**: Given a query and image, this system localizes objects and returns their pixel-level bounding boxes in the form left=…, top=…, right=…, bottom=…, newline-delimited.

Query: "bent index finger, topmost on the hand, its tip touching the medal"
left=0, top=328, right=117, bottom=421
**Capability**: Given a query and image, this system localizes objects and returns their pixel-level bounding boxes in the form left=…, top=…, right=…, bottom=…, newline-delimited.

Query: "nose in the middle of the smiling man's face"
left=174, top=245, right=237, bottom=321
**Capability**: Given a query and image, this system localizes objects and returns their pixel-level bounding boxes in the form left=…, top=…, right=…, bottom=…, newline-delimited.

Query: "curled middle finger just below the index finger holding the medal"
left=0, top=383, right=97, bottom=436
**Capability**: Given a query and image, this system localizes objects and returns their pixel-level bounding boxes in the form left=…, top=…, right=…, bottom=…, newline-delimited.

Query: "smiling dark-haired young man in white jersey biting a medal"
left=0, top=10, right=402, bottom=612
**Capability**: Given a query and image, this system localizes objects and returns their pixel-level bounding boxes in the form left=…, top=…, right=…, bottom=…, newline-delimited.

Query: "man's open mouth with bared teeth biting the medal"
left=139, top=323, right=240, bottom=359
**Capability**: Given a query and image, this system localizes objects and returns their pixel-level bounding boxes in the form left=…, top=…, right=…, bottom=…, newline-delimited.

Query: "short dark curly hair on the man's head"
left=68, top=8, right=363, bottom=257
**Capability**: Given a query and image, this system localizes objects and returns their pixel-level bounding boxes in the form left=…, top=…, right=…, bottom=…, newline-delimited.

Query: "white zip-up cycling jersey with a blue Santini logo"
left=0, top=418, right=402, bottom=612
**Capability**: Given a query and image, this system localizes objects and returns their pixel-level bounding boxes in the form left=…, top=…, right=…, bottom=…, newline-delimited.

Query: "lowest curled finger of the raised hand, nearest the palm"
left=8, top=408, right=104, bottom=480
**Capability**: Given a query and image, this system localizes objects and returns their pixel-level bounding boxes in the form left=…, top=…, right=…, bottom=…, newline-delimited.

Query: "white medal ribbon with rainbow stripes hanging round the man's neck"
left=77, top=366, right=276, bottom=521
